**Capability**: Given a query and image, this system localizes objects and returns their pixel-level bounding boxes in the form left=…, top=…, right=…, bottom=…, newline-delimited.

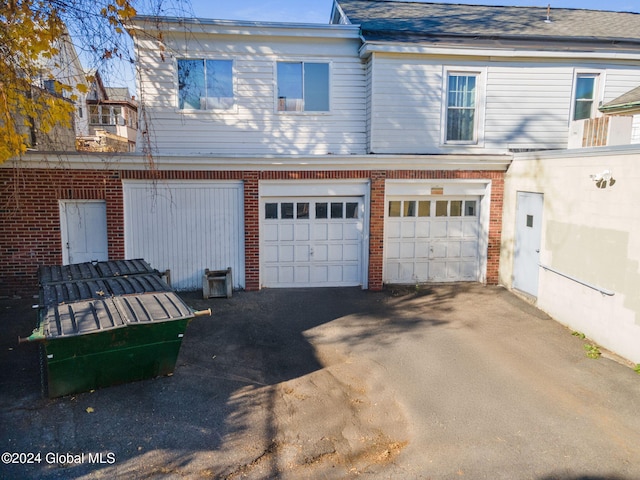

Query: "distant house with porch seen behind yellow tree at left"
left=77, top=72, right=138, bottom=152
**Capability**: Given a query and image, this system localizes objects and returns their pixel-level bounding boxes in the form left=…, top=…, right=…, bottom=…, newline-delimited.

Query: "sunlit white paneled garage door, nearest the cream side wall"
left=384, top=197, right=480, bottom=283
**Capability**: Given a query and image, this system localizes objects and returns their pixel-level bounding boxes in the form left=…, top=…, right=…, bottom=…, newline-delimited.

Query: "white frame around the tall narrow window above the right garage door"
left=440, top=66, right=487, bottom=147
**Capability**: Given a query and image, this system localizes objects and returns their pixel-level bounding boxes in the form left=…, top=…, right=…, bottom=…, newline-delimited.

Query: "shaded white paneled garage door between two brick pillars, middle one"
left=260, top=197, right=364, bottom=287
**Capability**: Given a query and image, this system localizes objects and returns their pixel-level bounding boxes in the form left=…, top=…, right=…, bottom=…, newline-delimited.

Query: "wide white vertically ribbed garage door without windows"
left=124, top=181, right=244, bottom=290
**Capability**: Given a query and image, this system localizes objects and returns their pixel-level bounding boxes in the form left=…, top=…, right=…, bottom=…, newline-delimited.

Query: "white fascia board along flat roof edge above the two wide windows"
left=129, top=17, right=360, bottom=39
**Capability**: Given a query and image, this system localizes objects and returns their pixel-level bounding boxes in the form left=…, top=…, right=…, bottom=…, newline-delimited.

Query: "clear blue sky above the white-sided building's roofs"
left=191, top=0, right=640, bottom=23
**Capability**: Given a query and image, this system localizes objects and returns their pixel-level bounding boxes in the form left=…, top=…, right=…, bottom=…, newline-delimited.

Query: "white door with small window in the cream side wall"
left=513, top=192, right=544, bottom=297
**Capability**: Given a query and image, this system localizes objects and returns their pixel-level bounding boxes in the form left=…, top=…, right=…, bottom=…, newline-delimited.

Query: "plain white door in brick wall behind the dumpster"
left=59, top=200, right=109, bottom=265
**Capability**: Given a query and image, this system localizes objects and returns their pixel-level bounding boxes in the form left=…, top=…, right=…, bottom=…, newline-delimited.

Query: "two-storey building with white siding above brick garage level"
left=0, top=0, right=640, bottom=328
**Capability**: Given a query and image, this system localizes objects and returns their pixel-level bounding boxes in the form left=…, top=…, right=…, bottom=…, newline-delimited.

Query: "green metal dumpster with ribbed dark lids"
left=21, top=258, right=211, bottom=398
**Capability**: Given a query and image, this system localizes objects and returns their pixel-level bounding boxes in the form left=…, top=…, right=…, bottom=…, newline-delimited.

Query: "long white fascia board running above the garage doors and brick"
left=8, top=152, right=513, bottom=171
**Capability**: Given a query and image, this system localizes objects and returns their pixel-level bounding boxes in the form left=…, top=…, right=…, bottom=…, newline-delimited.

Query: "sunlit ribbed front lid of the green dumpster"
left=41, top=292, right=193, bottom=339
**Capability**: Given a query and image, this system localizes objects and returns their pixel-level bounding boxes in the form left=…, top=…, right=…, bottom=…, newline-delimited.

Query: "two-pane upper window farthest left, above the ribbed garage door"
left=178, top=59, right=234, bottom=110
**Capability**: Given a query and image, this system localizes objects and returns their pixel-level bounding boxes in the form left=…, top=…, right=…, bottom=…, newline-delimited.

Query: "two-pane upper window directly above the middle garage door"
left=277, top=62, right=329, bottom=112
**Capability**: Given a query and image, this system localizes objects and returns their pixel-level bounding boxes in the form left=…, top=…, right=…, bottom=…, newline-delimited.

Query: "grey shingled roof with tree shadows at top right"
left=336, top=0, right=640, bottom=48
